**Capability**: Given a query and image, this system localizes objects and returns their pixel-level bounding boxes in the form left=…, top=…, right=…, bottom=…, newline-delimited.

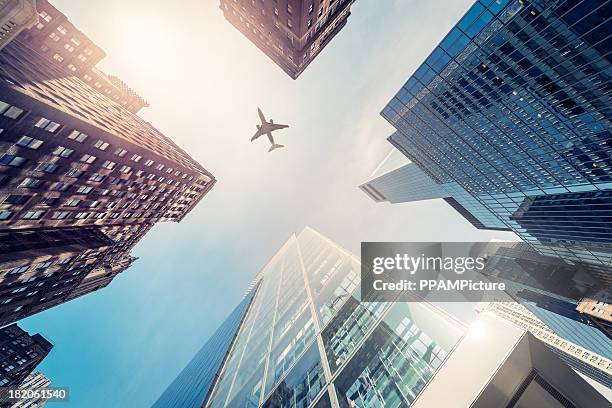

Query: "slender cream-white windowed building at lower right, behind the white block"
left=476, top=299, right=612, bottom=388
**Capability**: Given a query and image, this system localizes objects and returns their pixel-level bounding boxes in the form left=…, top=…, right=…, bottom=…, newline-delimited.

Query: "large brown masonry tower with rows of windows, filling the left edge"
left=0, top=21, right=215, bottom=324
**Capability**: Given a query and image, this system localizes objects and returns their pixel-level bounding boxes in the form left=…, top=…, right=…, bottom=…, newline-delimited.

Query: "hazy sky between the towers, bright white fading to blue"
left=20, top=0, right=515, bottom=408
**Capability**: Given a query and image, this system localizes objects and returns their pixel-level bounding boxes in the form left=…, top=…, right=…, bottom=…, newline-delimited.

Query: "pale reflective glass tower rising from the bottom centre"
left=206, top=228, right=465, bottom=408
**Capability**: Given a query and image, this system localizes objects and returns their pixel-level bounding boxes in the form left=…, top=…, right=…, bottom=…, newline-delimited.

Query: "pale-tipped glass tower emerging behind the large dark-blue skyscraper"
left=359, top=148, right=510, bottom=231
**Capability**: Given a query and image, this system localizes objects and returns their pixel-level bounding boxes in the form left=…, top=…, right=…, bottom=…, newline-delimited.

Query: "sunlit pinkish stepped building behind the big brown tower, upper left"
left=14, top=0, right=149, bottom=113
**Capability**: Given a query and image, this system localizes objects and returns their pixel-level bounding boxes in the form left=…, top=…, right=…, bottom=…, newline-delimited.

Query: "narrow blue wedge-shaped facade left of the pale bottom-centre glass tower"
left=153, top=287, right=257, bottom=408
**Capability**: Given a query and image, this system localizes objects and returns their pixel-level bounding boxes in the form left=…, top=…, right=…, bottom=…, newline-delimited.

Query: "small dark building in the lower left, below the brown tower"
left=0, top=324, right=53, bottom=387
